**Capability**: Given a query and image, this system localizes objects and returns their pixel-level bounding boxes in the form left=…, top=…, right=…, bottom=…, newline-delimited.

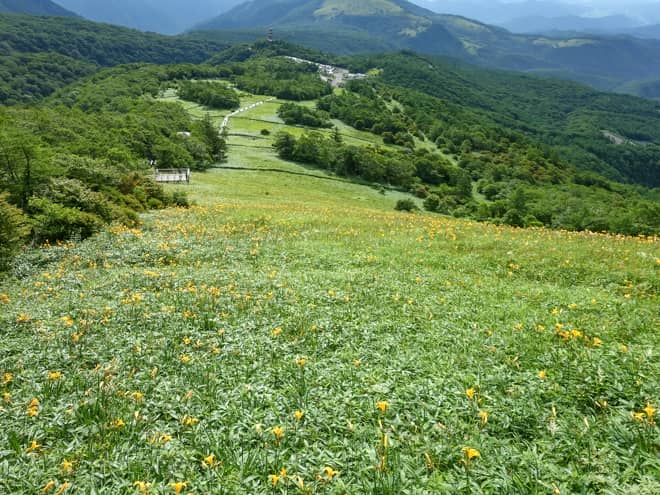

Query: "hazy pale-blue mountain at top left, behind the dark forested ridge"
left=59, top=0, right=240, bottom=34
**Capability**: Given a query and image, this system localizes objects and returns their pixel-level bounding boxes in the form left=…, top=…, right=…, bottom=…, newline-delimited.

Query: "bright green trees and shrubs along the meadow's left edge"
left=0, top=66, right=226, bottom=269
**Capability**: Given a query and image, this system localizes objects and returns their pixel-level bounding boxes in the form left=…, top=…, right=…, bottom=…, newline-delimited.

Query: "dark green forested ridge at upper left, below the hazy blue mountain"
left=0, top=14, right=227, bottom=103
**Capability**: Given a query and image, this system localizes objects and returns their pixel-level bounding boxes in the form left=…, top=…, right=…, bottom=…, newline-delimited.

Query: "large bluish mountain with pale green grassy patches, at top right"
left=196, top=0, right=660, bottom=90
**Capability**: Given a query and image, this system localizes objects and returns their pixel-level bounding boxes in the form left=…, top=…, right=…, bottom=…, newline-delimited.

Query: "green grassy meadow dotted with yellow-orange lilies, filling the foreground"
left=0, top=95, right=660, bottom=495
